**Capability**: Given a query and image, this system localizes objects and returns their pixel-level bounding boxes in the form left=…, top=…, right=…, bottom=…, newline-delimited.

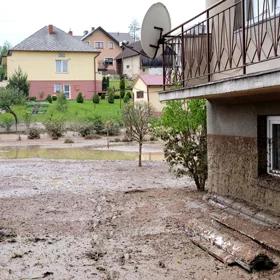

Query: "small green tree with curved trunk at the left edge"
left=0, top=88, right=25, bottom=135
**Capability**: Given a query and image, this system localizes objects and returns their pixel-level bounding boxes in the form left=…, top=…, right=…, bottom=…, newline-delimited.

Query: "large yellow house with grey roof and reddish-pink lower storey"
left=7, top=25, right=101, bottom=99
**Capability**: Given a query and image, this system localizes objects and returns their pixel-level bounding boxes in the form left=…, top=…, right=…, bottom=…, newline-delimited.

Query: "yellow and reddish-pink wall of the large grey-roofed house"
left=8, top=51, right=101, bottom=99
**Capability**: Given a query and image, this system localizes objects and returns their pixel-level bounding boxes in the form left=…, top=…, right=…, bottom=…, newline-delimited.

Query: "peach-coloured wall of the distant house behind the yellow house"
left=84, top=30, right=121, bottom=74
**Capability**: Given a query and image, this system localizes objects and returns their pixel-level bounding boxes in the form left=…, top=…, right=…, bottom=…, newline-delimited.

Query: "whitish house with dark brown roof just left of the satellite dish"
left=116, top=41, right=162, bottom=79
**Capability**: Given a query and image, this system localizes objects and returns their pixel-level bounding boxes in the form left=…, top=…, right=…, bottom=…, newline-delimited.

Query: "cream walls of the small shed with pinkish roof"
left=132, top=79, right=164, bottom=113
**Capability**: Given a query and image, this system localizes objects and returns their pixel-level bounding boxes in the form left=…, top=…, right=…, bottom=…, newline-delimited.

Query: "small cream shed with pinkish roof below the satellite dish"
left=133, top=74, right=164, bottom=113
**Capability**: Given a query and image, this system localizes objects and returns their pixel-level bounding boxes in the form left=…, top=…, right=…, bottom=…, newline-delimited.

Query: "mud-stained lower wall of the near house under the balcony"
left=207, top=100, right=280, bottom=214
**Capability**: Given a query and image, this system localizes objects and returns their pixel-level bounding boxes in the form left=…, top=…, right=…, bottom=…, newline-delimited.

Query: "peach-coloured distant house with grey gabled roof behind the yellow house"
left=81, top=26, right=132, bottom=74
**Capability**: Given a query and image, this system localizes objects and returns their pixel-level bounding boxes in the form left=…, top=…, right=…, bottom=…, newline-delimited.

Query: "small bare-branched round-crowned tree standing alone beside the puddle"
left=123, top=102, right=152, bottom=167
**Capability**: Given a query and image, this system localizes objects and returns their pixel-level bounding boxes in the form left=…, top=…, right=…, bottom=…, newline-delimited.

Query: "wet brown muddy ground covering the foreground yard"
left=0, top=159, right=280, bottom=280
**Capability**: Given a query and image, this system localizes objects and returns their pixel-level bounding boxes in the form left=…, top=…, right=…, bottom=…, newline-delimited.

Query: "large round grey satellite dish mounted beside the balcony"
left=141, top=3, right=171, bottom=58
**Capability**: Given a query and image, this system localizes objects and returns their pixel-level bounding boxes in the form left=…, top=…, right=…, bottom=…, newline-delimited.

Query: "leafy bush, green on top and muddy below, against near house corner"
left=153, top=100, right=207, bottom=191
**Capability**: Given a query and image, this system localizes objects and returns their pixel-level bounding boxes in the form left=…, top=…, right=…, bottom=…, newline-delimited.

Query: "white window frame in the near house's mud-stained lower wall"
left=267, top=116, right=280, bottom=176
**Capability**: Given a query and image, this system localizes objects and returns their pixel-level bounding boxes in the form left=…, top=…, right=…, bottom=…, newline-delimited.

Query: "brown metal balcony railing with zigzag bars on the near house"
left=163, top=0, right=280, bottom=90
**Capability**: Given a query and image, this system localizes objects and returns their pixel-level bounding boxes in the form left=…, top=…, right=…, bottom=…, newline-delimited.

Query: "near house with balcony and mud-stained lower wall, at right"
left=160, top=0, right=280, bottom=215
